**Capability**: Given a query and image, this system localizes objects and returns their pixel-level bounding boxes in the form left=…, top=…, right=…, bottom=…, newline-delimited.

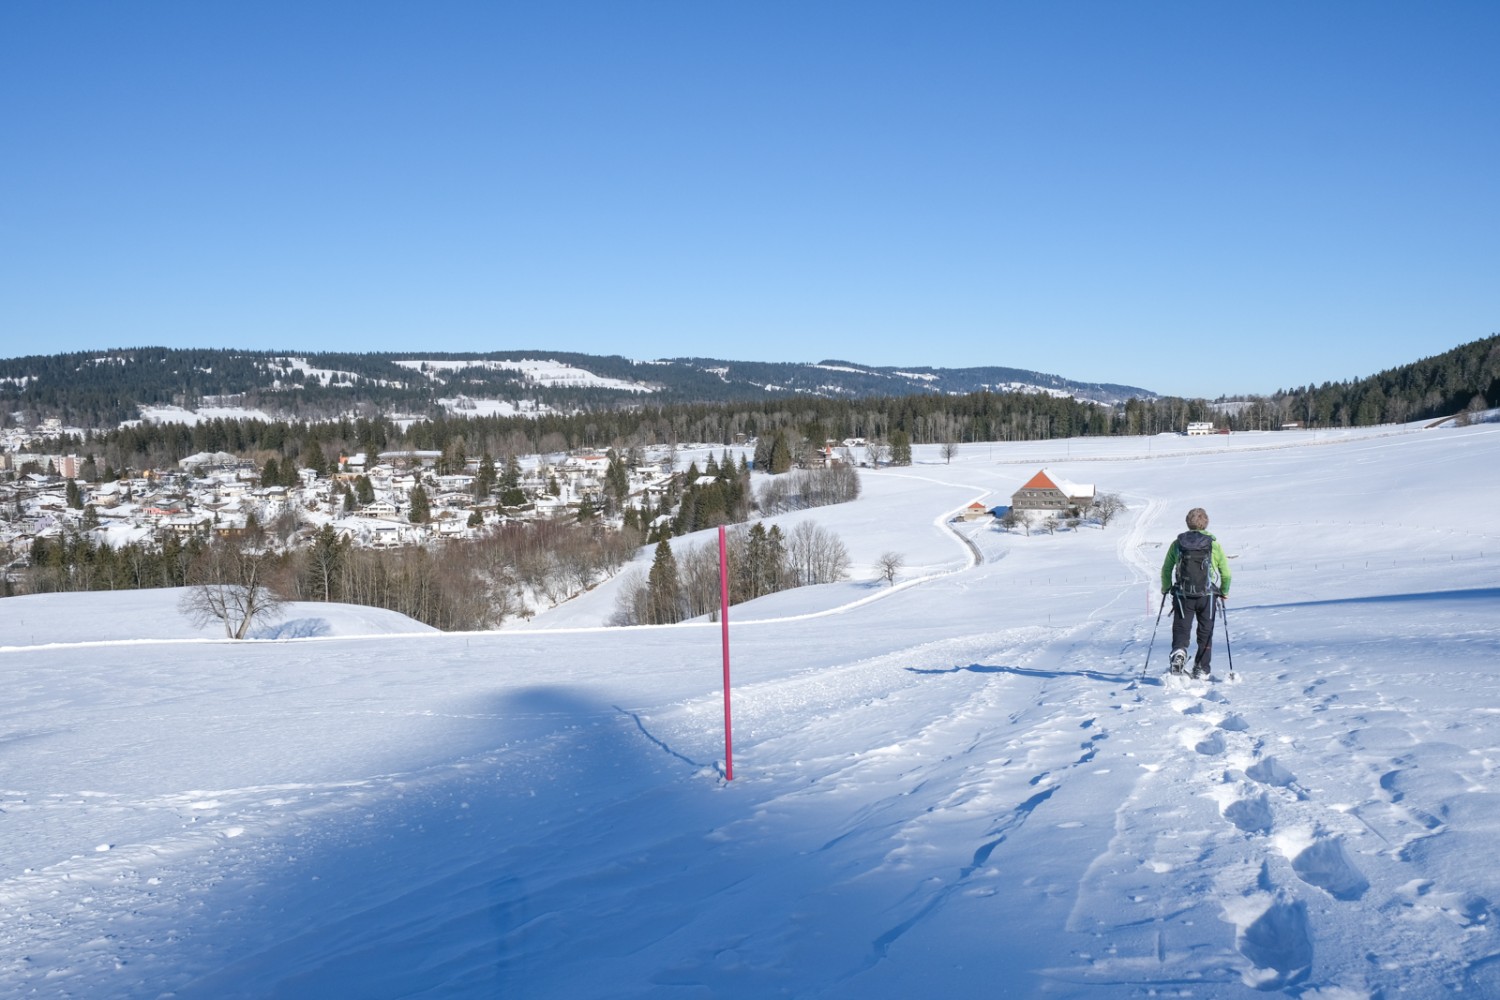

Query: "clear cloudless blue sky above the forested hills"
left=0, top=0, right=1500, bottom=396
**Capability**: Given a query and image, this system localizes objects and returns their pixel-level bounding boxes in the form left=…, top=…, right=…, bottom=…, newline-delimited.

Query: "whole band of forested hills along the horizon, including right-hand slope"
left=0, top=334, right=1500, bottom=441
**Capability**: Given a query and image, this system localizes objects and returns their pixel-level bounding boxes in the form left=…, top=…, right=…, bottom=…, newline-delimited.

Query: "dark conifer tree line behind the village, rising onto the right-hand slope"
left=32, top=336, right=1500, bottom=471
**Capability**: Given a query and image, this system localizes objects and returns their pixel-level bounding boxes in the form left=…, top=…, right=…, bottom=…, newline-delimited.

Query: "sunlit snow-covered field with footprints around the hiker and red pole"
left=0, top=424, right=1500, bottom=1000
